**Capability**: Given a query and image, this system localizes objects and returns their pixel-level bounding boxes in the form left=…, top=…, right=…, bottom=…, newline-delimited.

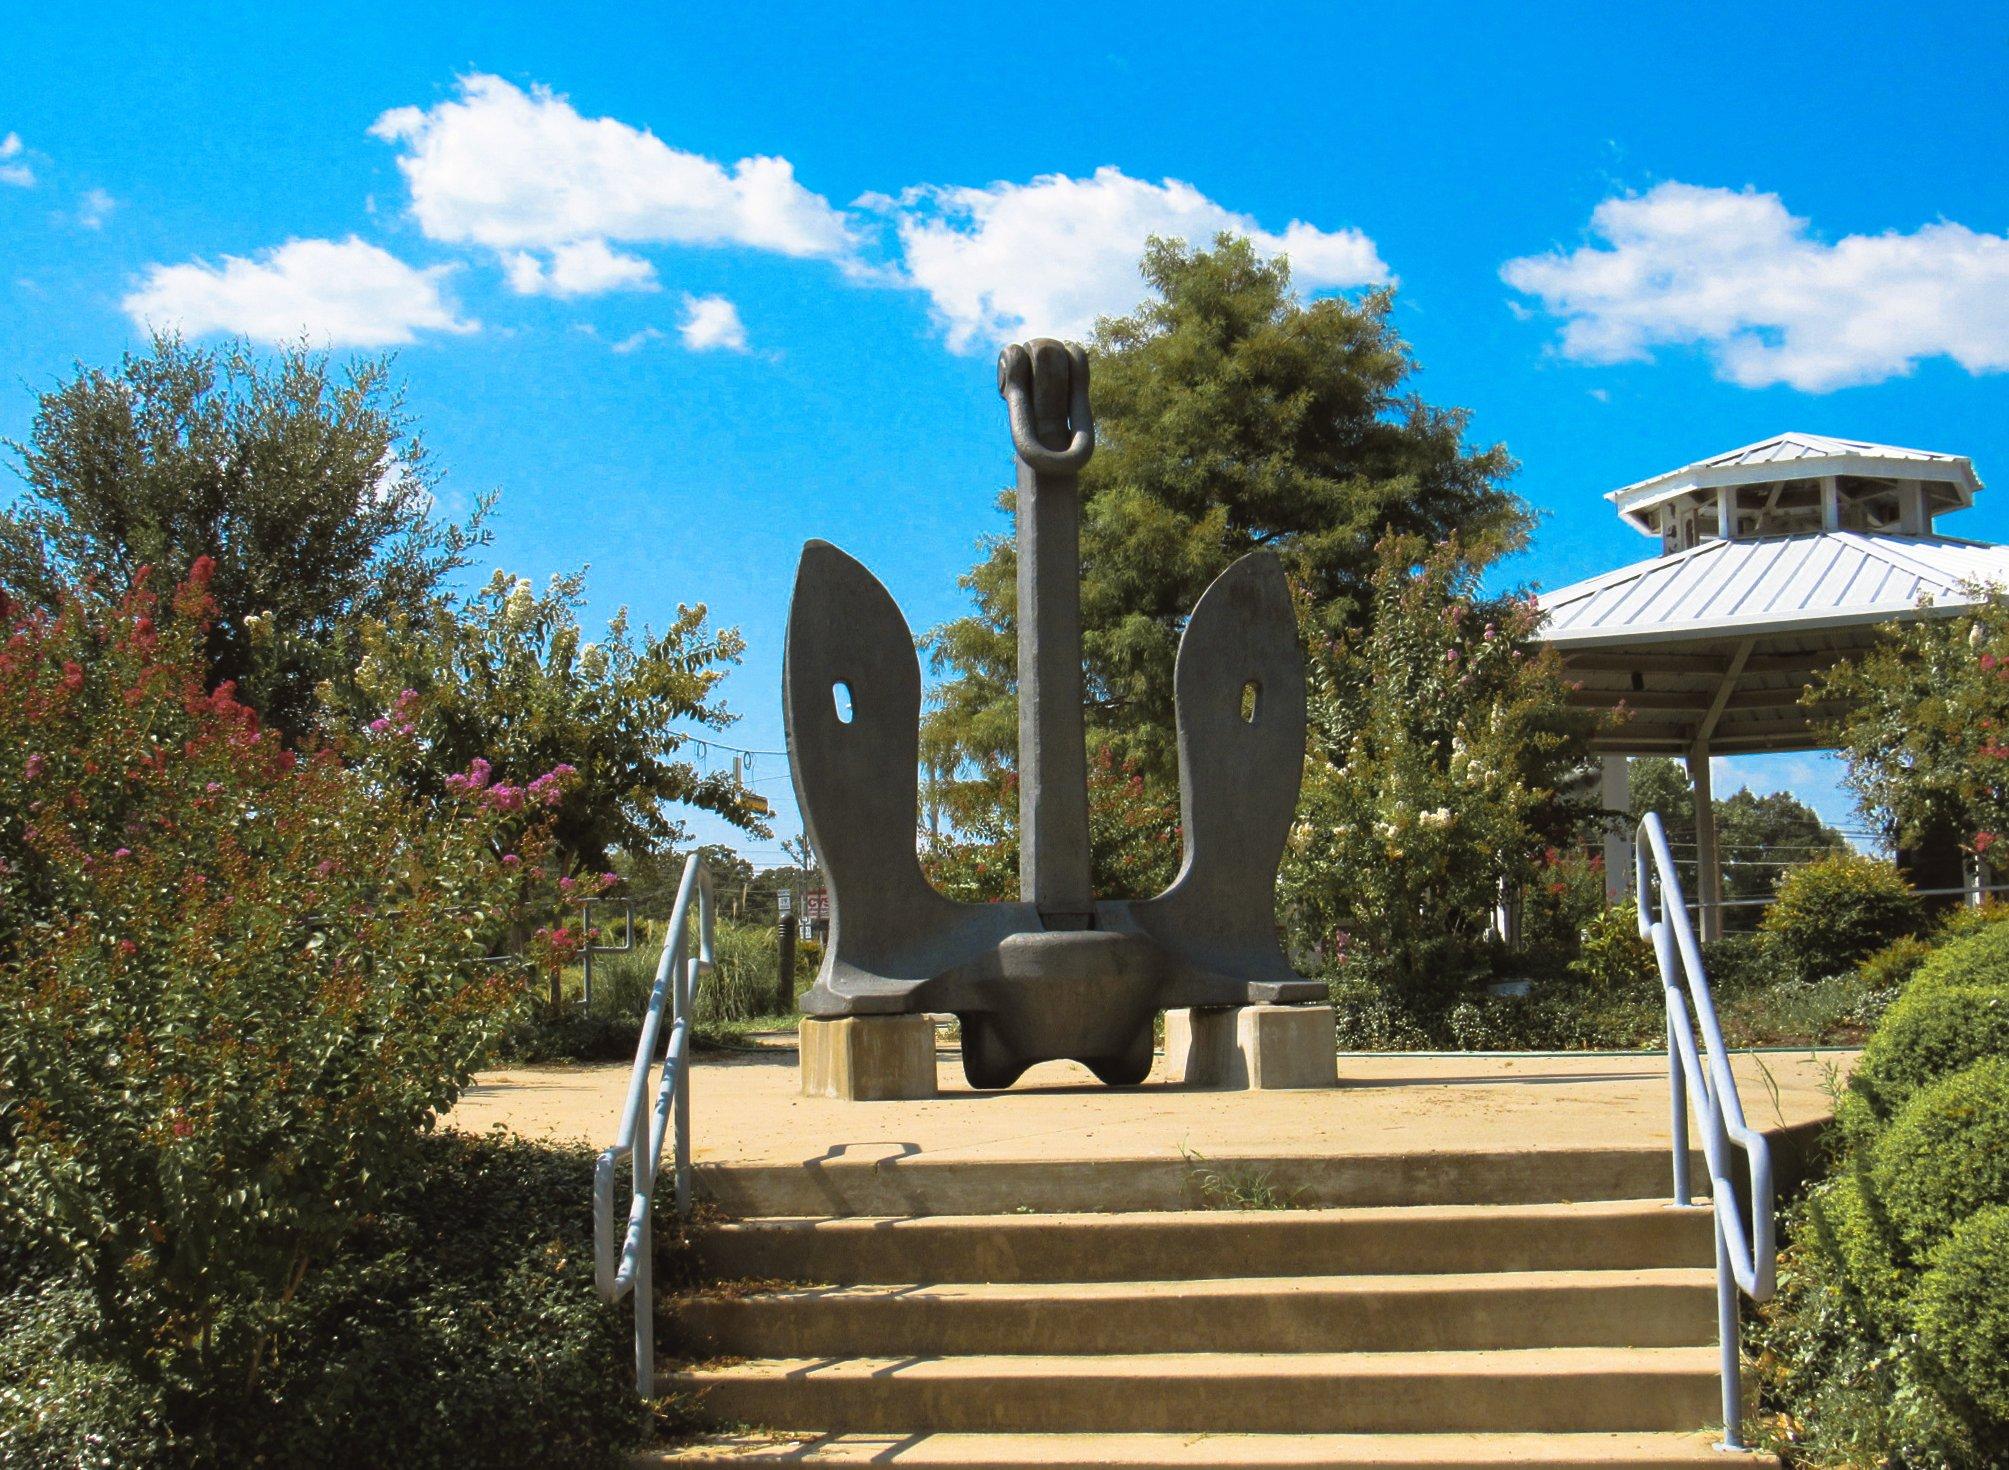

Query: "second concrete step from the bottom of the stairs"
left=657, top=1348, right=1720, bottom=1434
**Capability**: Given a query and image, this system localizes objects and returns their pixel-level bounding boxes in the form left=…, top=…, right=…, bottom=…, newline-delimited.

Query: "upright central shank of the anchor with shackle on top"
left=998, top=339, right=1095, bottom=928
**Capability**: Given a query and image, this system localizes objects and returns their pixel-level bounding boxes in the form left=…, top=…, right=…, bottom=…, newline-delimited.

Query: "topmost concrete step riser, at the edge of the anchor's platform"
left=697, top=1145, right=1708, bottom=1217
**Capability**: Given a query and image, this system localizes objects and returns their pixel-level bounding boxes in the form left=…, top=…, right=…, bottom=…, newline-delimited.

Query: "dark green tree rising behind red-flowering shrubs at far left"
left=0, top=335, right=486, bottom=733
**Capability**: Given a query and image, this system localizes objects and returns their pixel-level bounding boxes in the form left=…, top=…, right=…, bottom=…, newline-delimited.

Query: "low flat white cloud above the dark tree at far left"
left=121, top=235, right=476, bottom=347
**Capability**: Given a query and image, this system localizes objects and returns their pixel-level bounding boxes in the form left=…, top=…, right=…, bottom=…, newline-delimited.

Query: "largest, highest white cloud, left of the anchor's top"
left=370, top=74, right=854, bottom=295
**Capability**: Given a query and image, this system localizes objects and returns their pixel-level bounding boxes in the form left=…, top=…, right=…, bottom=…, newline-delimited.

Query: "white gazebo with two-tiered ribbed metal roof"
left=1541, top=434, right=2009, bottom=938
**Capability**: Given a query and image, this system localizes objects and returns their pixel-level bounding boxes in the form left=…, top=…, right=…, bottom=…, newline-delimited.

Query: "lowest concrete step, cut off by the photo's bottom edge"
left=629, top=1434, right=1778, bottom=1470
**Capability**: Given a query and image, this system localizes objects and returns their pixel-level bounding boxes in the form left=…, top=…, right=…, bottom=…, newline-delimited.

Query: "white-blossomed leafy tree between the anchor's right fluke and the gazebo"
left=1280, top=538, right=1597, bottom=1004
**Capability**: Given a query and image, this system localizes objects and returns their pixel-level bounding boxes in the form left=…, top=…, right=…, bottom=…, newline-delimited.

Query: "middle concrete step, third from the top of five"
left=667, top=1263, right=1716, bottom=1358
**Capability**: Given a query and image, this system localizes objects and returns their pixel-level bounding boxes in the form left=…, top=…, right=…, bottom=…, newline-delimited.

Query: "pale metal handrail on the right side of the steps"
left=1633, top=811, right=1778, bottom=1450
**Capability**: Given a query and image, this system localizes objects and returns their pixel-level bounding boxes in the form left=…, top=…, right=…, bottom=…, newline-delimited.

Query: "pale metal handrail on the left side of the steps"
left=593, top=855, right=715, bottom=1398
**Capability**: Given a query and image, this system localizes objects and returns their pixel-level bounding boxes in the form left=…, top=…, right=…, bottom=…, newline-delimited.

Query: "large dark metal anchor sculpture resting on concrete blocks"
left=782, top=339, right=1324, bottom=1088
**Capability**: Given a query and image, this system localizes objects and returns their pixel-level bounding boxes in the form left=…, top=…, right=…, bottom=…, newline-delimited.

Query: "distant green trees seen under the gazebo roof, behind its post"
left=1631, top=755, right=1850, bottom=902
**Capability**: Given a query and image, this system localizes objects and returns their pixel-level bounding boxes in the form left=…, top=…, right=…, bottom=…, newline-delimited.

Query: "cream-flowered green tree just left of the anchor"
left=345, top=570, right=765, bottom=882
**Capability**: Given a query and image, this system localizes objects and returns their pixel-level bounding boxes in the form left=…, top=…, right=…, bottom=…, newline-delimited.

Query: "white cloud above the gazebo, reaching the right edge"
left=1501, top=183, right=2009, bottom=394
